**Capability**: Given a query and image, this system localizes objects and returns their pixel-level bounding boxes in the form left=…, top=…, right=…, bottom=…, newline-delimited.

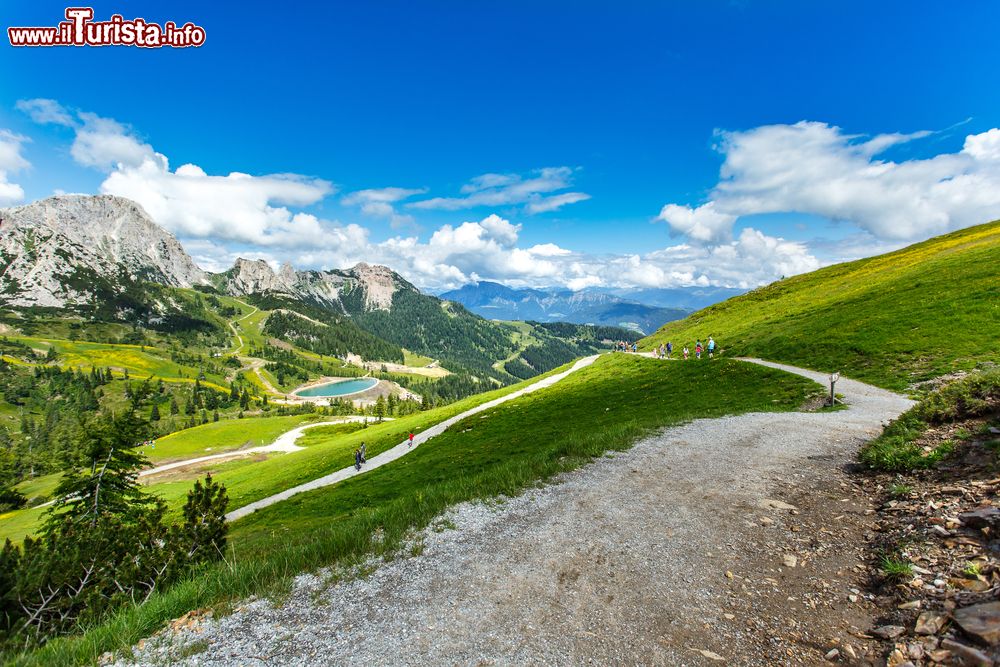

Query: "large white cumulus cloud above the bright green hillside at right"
left=659, top=121, right=1000, bottom=242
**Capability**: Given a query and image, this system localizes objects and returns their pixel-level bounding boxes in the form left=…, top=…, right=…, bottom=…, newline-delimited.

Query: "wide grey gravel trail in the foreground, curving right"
left=115, top=360, right=912, bottom=665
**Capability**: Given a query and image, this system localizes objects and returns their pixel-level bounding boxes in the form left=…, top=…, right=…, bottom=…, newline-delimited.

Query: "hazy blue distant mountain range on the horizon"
left=440, top=281, right=742, bottom=333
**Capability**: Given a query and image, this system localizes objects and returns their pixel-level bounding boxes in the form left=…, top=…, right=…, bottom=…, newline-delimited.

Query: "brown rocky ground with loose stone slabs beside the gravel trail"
left=862, top=416, right=1000, bottom=667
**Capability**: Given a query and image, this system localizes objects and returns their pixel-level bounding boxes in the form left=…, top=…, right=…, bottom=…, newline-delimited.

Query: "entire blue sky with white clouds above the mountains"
left=0, top=0, right=1000, bottom=289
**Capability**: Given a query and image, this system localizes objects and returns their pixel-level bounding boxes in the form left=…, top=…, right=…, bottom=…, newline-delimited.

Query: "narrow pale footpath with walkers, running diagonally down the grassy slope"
left=226, top=355, right=597, bottom=521
